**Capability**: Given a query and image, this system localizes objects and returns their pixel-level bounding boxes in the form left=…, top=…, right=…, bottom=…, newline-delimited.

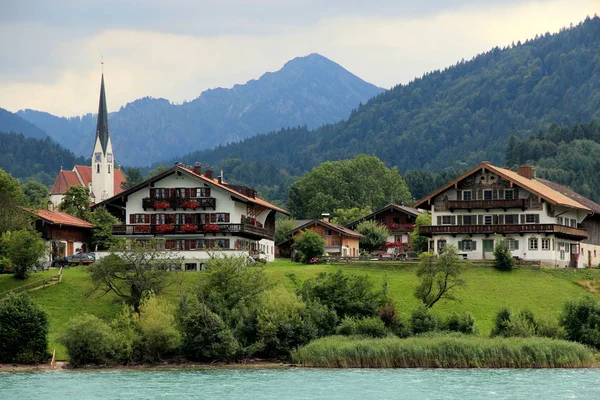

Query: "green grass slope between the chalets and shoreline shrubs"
left=0, top=259, right=600, bottom=359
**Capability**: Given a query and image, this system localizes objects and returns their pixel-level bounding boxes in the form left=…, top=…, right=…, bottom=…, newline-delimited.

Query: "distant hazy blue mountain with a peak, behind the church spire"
left=18, top=54, right=383, bottom=165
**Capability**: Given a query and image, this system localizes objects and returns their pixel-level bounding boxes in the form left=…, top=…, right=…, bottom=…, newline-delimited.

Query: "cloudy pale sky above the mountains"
left=0, top=0, right=600, bottom=116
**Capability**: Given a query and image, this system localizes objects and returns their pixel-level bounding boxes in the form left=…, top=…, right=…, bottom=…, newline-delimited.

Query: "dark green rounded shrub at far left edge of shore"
left=0, top=293, right=49, bottom=364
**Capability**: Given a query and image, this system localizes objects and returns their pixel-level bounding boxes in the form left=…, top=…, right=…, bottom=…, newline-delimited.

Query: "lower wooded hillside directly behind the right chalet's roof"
left=506, top=121, right=600, bottom=202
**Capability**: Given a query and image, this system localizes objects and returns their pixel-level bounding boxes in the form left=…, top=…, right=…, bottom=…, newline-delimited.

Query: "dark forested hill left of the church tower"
left=0, top=132, right=90, bottom=186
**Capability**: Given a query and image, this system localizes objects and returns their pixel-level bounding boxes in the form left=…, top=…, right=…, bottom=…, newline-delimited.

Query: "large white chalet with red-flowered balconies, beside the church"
left=93, top=165, right=289, bottom=270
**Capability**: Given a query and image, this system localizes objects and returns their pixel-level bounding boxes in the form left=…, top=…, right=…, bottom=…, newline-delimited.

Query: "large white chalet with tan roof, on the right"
left=414, top=162, right=600, bottom=267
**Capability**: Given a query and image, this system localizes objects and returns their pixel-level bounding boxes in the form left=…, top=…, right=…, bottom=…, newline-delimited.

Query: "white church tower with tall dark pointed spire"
left=90, top=74, right=115, bottom=203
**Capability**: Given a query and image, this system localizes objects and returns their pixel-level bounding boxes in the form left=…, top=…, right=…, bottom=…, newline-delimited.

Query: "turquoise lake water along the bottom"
left=0, top=368, right=600, bottom=400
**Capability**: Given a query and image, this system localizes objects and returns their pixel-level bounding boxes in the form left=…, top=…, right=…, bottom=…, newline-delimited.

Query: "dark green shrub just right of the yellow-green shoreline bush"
left=179, top=297, right=239, bottom=361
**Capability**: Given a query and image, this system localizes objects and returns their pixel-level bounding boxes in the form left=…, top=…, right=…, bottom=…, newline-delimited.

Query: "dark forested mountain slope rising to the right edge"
left=171, top=17, right=600, bottom=200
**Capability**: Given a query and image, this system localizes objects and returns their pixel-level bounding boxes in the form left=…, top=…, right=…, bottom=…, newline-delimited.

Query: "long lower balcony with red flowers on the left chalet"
left=112, top=224, right=273, bottom=239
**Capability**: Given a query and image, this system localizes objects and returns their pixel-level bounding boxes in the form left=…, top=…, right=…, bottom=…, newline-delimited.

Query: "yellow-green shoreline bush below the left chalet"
left=135, top=296, right=181, bottom=360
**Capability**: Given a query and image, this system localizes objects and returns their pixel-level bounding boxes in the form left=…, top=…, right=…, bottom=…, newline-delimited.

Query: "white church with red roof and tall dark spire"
left=50, top=74, right=126, bottom=207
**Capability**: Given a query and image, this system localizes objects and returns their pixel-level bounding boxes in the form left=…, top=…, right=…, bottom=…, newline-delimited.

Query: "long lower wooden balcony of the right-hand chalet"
left=419, top=224, right=588, bottom=240
